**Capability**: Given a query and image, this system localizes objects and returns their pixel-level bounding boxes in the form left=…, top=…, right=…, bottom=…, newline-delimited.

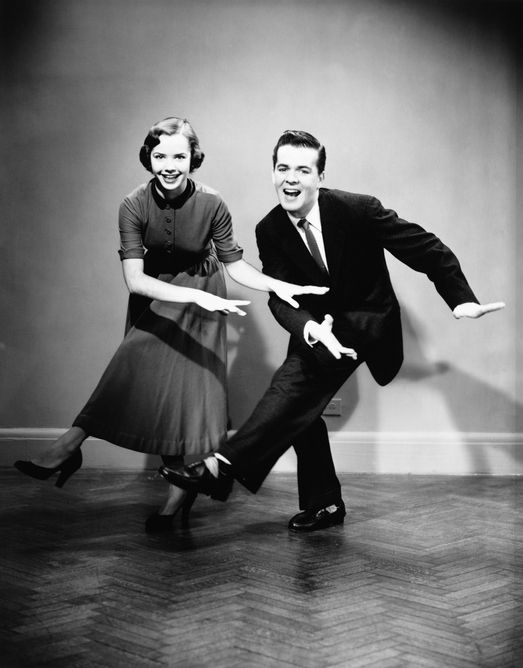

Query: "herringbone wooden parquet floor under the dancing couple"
left=0, top=470, right=523, bottom=668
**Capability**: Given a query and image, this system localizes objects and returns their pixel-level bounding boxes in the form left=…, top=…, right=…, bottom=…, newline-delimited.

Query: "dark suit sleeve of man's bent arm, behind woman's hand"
left=256, top=225, right=316, bottom=341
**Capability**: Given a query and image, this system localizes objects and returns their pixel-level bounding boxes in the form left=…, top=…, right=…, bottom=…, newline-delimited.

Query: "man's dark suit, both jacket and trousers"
left=218, top=188, right=478, bottom=509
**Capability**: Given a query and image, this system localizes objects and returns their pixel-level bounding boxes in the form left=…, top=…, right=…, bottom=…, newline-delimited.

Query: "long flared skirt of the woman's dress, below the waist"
left=73, top=254, right=227, bottom=455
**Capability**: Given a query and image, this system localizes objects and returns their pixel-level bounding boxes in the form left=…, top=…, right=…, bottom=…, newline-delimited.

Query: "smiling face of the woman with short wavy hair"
left=151, top=134, right=191, bottom=196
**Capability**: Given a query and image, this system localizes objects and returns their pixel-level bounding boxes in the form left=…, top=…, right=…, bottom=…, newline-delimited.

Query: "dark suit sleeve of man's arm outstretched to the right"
left=366, top=197, right=479, bottom=309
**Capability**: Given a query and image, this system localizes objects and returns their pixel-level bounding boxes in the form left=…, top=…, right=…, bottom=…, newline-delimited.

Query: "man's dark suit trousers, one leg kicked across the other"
left=218, top=344, right=363, bottom=510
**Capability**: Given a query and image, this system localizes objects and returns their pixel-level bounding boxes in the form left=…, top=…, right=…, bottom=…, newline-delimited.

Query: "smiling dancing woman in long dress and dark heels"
left=15, top=117, right=326, bottom=532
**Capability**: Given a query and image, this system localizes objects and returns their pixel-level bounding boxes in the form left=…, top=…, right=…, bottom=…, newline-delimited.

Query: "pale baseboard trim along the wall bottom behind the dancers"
left=0, top=428, right=523, bottom=475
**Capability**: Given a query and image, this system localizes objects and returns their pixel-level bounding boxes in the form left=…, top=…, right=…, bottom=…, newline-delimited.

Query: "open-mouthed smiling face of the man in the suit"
left=272, top=145, right=323, bottom=218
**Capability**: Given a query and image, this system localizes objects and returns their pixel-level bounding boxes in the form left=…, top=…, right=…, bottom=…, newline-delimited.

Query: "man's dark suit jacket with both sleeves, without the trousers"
left=256, top=188, right=478, bottom=385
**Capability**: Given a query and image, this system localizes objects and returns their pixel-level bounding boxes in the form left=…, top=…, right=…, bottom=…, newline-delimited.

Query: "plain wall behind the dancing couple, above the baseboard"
left=0, top=0, right=523, bottom=454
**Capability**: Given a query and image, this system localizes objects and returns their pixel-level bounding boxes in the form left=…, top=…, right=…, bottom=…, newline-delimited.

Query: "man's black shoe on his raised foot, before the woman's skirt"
left=158, top=460, right=234, bottom=501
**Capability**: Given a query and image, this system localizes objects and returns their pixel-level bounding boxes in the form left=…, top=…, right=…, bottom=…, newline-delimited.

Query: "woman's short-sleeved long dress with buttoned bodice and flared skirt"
left=73, top=179, right=242, bottom=455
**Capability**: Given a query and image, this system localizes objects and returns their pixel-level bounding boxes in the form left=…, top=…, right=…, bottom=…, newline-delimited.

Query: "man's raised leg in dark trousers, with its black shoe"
left=160, top=346, right=362, bottom=503
